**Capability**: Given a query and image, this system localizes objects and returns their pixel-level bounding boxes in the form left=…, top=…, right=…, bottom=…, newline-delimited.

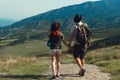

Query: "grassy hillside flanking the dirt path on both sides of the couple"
left=0, top=26, right=120, bottom=80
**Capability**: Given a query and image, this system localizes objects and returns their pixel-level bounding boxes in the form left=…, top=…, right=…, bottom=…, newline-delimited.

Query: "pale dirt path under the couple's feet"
left=45, top=63, right=110, bottom=80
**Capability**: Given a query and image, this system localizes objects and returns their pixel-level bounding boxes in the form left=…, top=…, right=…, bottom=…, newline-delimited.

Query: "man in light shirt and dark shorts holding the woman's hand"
left=69, top=14, right=90, bottom=76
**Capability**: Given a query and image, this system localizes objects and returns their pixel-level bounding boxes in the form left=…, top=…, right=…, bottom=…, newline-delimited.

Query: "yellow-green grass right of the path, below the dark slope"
left=86, top=45, right=120, bottom=80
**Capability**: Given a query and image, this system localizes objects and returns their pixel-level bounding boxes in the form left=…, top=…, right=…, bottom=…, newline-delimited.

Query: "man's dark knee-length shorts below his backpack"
left=73, top=45, right=86, bottom=59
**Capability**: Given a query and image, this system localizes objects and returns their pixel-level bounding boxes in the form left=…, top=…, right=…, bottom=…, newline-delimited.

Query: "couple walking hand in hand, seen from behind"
left=48, top=14, right=90, bottom=79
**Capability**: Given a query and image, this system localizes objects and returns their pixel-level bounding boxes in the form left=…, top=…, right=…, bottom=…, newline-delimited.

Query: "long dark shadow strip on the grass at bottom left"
left=0, top=75, right=51, bottom=80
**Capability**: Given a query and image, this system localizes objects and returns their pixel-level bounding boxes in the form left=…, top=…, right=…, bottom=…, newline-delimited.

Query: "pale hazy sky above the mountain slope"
left=0, top=0, right=96, bottom=20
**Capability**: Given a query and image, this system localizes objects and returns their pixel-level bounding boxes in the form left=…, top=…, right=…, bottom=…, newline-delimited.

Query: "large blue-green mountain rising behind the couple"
left=0, top=0, right=120, bottom=39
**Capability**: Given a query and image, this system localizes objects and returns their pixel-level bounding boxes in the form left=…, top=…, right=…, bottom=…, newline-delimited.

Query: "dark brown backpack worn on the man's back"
left=75, top=23, right=91, bottom=46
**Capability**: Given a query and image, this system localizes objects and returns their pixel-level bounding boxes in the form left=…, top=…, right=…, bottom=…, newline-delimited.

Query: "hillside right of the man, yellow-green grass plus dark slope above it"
left=86, top=35, right=120, bottom=80
